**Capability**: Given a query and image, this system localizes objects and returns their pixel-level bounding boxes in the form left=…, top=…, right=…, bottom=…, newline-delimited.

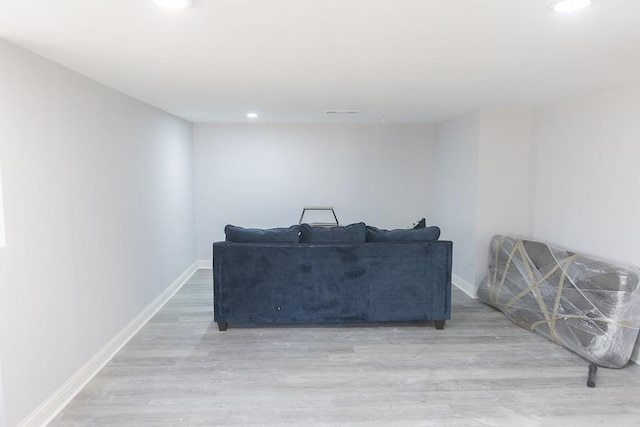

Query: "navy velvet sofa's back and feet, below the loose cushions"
left=213, top=225, right=453, bottom=331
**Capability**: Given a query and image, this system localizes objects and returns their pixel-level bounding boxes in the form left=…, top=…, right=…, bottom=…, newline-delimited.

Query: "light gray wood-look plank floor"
left=50, top=270, right=640, bottom=427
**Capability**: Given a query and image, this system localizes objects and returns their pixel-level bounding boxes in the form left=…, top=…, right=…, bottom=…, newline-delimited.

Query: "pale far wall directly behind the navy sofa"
left=194, top=124, right=433, bottom=260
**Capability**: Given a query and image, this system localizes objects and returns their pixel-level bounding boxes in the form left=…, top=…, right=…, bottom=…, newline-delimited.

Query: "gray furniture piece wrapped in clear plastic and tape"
left=478, top=236, right=640, bottom=368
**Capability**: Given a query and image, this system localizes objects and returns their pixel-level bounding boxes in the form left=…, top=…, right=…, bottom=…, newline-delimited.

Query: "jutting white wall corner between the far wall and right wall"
left=431, top=109, right=533, bottom=295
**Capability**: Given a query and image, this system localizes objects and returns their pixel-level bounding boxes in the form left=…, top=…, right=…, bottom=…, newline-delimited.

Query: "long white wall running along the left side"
left=0, top=40, right=196, bottom=426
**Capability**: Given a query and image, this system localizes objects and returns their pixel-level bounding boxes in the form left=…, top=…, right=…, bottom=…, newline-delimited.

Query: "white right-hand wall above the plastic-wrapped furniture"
left=534, top=83, right=640, bottom=265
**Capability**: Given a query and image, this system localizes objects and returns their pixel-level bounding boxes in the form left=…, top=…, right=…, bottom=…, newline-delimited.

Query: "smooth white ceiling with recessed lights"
left=0, top=0, right=640, bottom=123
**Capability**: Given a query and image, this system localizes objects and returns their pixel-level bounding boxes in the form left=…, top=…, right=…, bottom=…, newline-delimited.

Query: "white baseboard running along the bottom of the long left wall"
left=18, top=262, right=199, bottom=427
